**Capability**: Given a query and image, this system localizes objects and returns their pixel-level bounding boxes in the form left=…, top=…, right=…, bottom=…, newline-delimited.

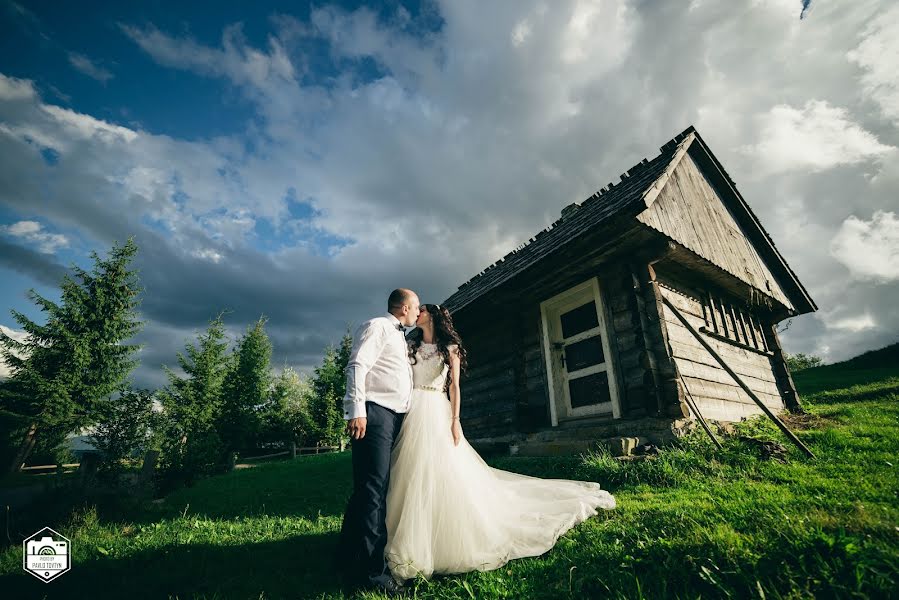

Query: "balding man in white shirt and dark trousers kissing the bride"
left=335, top=289, right=419, bottom=595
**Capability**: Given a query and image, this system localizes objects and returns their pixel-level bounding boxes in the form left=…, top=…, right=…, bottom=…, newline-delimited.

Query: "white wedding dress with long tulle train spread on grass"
left=384, top=344, right=615, bottom=579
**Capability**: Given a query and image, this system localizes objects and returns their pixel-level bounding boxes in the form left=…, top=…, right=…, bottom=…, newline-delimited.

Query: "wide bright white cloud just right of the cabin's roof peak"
left=742, top=100, right=896, bottom=174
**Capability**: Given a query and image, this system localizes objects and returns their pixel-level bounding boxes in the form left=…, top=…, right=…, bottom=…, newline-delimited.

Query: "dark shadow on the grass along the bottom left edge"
left=0, top=533, right=340, bottom=600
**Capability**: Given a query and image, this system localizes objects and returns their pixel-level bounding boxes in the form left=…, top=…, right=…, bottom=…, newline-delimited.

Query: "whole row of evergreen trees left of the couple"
left=0, top=239, right=352, bottom=487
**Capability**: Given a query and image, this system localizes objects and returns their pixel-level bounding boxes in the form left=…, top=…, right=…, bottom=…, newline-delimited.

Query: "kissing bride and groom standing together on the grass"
left=334, top=289, right=615, bottom=596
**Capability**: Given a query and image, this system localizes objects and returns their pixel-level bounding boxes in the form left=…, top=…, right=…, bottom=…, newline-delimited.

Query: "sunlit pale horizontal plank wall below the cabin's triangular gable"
left=659, top=282, right=784, bottom=421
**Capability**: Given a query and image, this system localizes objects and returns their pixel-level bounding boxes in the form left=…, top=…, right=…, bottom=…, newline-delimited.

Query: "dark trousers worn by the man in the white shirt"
left=334, top=402, right=405, bottom=584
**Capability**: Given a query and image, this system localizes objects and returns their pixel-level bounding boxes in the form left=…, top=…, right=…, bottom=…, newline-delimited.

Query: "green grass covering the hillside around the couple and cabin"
left=0, top=356, right=899, bottom=599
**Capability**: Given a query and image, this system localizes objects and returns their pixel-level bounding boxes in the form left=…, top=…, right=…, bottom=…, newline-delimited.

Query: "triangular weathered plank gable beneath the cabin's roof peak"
left=637, top=153, right=793, bottom=310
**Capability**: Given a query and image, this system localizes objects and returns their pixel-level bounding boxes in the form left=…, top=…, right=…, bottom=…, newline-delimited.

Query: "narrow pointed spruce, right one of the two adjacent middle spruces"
left=217, top=317, right=272, bottom=455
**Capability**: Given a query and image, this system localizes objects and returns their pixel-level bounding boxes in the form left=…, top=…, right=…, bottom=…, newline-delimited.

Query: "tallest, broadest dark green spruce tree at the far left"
left=0, top=238, right=141, bottom=472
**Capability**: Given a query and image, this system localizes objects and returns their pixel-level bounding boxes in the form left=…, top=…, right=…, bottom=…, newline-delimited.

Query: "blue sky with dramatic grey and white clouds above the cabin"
left=0, top=0, right=899, bottom=388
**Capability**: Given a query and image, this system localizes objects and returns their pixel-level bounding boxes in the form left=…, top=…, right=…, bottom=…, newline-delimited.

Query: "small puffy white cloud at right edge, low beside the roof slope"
left=830, top=210, right=899, bottom=282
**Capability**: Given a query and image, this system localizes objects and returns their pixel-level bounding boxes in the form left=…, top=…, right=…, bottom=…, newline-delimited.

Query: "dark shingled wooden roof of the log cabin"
left=443, top=125, right=817, bottom=314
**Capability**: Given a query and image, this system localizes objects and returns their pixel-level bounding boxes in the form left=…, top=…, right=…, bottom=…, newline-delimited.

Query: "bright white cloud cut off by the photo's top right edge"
left=847, top=4, right=899, bottom=124
